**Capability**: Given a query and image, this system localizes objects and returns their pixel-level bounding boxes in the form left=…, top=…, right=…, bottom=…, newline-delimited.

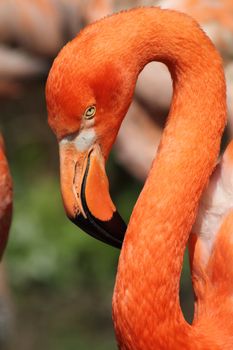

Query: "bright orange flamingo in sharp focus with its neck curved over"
left=46, top=8, right=233, bottom=350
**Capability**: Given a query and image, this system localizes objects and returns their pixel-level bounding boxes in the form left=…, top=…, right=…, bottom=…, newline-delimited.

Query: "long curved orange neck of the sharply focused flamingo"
left=113, top=8, right=226, bottom=350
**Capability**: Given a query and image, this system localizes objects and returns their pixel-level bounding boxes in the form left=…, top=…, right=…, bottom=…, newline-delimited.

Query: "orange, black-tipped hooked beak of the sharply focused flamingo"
left=59, top=141, right=127, bottom=248
